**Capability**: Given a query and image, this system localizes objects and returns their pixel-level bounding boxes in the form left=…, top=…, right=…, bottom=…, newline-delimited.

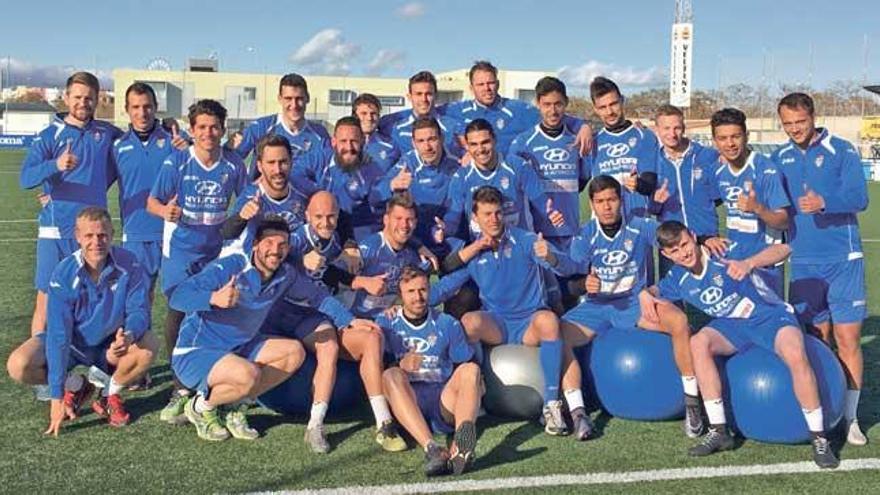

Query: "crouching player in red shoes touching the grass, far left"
left=7, top=206, right=157, bottom=436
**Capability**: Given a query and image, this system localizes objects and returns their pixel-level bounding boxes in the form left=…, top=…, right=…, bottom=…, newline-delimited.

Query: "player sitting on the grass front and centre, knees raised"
left=376, top=266, right=482, bottom=476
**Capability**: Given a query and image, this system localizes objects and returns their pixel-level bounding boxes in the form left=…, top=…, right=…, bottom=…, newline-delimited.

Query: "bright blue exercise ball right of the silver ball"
left=578, top=328, right=684, bottom=421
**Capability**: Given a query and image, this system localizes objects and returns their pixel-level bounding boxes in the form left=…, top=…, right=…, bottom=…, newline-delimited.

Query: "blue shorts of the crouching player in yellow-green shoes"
left=171, top=335, right=267, bottom=397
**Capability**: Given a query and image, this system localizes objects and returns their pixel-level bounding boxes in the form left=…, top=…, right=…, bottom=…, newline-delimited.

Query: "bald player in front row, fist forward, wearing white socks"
left=262, top=191, right=406, bottom=453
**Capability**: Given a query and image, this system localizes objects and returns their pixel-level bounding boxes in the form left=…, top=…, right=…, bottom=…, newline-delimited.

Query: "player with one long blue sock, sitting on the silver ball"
left=436, top=186, right=575, bottom=435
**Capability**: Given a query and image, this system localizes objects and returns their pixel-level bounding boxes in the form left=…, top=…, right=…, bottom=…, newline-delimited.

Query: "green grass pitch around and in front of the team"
left=0, top=151, right=880, bottom=494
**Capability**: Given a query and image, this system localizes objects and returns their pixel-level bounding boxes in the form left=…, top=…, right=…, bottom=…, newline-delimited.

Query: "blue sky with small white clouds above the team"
left=0, top=0, right=880, bottom=94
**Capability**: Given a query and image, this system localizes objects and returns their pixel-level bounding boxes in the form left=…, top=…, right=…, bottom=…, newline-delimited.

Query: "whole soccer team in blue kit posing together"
left=7, top=61, right=868, bottom=475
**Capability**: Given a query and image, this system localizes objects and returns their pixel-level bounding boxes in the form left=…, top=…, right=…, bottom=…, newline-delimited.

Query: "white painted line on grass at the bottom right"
left=253, top=458, right=880, bottom=495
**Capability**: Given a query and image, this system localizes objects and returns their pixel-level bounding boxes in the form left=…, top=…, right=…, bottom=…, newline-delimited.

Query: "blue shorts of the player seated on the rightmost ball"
left=703, top=306, right=800, bottom=354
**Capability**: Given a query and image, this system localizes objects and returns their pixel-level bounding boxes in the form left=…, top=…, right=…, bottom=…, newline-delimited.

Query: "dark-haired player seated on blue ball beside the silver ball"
left=562, top=175, right=703, bottom=440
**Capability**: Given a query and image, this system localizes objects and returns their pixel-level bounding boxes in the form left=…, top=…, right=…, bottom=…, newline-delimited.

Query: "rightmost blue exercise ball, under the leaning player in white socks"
left=724, top=335, right=846, bottom=443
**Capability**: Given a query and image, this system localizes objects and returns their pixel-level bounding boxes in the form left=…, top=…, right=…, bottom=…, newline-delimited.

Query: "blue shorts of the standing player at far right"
left=789, top=258, right=868, bottom=325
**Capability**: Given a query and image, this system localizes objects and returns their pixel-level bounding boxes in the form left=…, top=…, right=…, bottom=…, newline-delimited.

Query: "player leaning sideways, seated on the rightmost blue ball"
left=642, top=221, right=839, bottom=468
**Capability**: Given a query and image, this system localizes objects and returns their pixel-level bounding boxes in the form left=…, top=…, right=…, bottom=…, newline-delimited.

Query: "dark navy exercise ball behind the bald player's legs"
left=258, top=353, right=364, bottom=416
